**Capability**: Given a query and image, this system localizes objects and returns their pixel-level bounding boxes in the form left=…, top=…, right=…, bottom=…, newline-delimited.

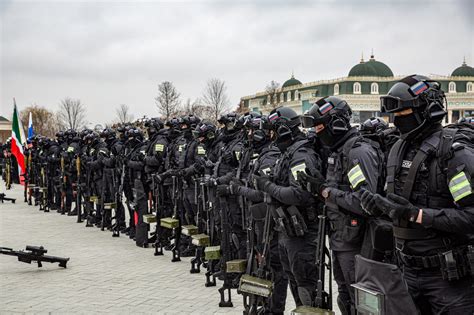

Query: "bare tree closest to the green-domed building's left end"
left=202, top=79, right=229, bottom=122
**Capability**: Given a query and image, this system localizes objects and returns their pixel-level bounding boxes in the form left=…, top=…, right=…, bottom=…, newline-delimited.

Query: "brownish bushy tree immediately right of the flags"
left=20, top=104, right=59, bottom=138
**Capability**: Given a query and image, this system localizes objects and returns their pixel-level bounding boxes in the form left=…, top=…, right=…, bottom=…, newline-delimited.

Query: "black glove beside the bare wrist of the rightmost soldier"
left=374, top=194, right=419, bottom=222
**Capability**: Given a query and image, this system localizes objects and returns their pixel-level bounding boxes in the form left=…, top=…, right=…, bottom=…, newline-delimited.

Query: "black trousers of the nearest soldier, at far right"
left=400, top=266, right=474, bottom=315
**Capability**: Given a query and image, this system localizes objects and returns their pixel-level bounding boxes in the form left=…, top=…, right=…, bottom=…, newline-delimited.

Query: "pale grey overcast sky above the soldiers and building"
left=0, top=0, right=474, bottom=124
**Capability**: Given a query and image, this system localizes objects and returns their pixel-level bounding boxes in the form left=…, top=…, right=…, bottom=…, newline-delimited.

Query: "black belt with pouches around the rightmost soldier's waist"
left=397, top=245, right=474, bottom=281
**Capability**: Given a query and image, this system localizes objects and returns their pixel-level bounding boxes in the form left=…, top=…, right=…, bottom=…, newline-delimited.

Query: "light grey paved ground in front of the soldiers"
left=0, top=185, right=337, bottom=314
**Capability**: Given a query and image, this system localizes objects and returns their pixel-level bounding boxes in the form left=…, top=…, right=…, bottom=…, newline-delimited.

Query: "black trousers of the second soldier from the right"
left=332, top=250, right=360, bottom=315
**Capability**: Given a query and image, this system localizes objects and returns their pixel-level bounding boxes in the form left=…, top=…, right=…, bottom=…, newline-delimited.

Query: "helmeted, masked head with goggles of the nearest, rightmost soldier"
left=380, top=75, right=446, bottom=139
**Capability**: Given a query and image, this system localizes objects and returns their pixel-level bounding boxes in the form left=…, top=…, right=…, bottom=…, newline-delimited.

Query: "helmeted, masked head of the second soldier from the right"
left=301, top=96, right=352, bottom=147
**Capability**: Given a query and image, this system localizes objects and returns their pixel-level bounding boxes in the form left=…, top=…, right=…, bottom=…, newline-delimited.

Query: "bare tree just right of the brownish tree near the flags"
left=57, top=97, right=87, bottom=130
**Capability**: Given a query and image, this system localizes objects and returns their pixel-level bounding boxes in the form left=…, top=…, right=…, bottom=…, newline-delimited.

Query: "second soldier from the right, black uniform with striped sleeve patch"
left=301, top=96, right=384, bottom=314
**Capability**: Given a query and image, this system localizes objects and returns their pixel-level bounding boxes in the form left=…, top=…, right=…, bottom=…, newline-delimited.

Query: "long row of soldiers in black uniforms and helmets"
left=3, top=75, right=474, bottom=314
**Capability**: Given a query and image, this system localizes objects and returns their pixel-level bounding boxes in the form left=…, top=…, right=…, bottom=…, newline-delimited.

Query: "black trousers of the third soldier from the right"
left=278, top=223, right=318, bottom=306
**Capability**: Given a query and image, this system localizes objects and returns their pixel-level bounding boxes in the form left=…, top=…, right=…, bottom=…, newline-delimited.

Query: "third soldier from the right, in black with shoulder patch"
left=254, top=107, right=321, bottom=306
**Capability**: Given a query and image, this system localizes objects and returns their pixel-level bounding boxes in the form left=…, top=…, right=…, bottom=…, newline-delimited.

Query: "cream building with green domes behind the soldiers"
left=240, top=54, right=474, bottom=123
